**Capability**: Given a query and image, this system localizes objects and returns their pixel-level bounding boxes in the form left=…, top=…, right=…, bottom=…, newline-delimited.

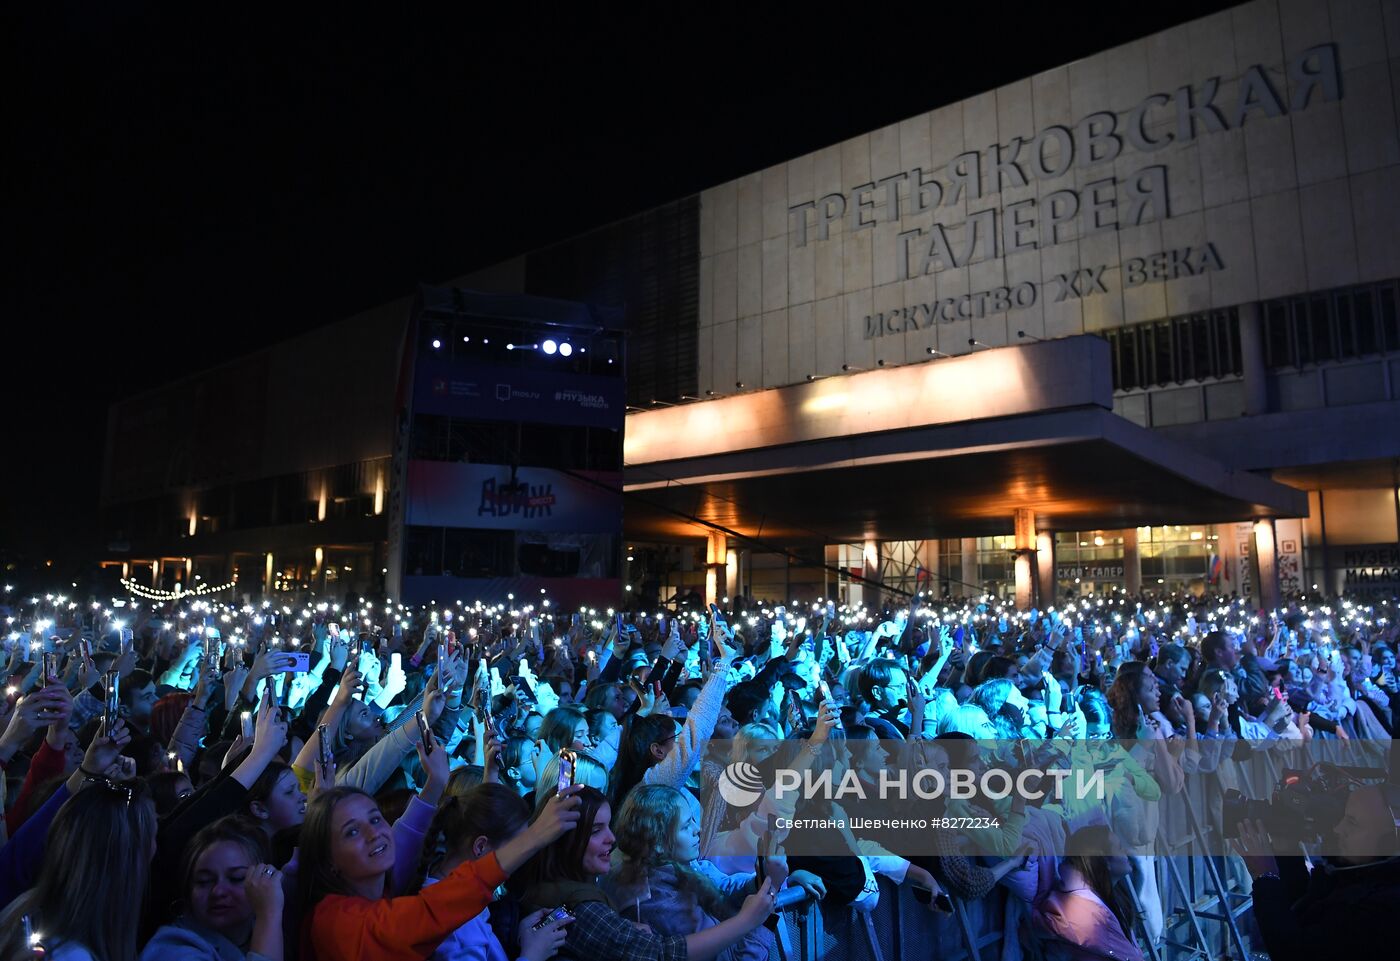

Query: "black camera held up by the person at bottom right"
left=1221, top=762, right=1386, bottom=843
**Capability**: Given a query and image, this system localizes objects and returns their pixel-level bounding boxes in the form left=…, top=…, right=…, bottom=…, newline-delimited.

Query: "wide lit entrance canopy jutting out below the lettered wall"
left=624, top=336, right=1308, bottom=544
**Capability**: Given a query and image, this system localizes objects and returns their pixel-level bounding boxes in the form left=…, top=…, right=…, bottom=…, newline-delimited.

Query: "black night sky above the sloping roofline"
left=8, top=1, right=1229, bottom=558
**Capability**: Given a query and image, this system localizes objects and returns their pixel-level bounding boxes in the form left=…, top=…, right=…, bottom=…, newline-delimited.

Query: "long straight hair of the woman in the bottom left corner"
left=0, top=780, right=155, bottom=961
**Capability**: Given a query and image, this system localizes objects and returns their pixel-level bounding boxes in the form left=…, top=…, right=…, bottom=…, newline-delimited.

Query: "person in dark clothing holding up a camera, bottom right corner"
left=1236, top=786, right=1400, bottom=961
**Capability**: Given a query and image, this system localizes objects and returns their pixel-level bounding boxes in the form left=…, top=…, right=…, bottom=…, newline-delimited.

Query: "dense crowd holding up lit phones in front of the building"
left=0, top=594, right=1400, bottom=961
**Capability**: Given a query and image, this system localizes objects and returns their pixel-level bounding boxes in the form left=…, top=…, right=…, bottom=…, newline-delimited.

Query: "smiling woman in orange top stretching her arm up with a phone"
left=298, top=787, right=578, bottom=961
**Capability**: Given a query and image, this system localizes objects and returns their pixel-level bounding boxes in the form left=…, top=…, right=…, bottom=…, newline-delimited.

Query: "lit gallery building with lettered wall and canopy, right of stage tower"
left=103, top=0, right=1400, bottom=602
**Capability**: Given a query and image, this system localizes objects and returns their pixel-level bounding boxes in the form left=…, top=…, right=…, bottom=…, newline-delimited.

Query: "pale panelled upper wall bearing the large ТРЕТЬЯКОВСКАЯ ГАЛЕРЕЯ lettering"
left=697, top=0, right=1400, bottom=391
